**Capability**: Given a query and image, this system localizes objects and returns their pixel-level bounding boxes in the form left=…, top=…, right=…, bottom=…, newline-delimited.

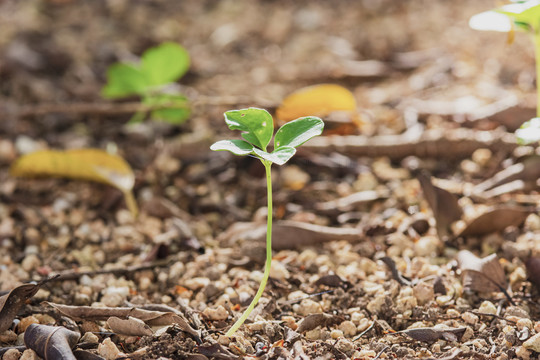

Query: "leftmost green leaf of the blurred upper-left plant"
left=102, top=64, right=148, bottom=99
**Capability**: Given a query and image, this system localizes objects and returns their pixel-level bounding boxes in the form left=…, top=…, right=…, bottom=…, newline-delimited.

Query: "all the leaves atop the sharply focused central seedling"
left=210, top=108, right=324, bottom=165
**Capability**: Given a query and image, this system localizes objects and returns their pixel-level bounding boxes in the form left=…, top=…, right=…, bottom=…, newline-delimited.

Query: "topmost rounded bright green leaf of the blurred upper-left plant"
left=141, top=42, right=190, bottom=86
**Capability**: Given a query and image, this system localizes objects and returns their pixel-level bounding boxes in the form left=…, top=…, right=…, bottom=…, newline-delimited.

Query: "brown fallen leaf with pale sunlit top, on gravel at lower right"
left=457, top=250, right=513, bottom=303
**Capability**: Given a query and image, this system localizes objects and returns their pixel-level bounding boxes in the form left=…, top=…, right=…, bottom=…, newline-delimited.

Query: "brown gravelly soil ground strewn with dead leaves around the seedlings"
left=0, top=0, right=540, bottom=360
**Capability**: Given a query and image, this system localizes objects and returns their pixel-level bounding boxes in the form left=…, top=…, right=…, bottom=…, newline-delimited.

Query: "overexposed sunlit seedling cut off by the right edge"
left=469, top=0, right=540, bottom=144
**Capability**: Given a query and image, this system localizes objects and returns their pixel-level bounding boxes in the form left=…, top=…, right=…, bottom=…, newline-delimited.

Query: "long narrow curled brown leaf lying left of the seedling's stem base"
left=47, top=302, right=200, bottom=341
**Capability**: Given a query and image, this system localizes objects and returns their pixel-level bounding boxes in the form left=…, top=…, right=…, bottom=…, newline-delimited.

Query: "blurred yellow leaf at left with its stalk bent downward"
left=9, top=149, right=138, bottom=216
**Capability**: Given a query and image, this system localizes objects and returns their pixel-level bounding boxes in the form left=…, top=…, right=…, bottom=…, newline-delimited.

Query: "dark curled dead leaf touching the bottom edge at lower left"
left=24, top=324, right=81, bottom=360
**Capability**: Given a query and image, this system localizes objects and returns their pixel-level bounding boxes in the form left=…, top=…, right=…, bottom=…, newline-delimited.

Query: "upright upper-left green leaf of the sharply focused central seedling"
left=225, top=108, right=274, bottom=150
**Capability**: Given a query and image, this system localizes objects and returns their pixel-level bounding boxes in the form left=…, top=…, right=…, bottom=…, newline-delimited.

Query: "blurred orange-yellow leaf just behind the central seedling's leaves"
left=276, top=84, right=356, bottom=122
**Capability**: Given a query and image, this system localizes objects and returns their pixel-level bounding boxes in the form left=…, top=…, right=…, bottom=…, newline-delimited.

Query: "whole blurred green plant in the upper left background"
left=102, top=42, right=190, bottom=124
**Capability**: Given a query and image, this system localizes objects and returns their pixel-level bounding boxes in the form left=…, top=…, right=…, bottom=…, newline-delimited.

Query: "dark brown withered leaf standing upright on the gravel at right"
left=418, top=174, right=463, bottom=238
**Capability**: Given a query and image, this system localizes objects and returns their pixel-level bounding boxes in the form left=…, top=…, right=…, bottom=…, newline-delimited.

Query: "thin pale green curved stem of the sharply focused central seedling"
left=225, top=159, right=272, bottom=336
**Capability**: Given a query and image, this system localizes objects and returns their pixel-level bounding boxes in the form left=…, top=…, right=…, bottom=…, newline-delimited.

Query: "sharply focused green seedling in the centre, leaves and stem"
left=210, top=108, right=324, bottom=336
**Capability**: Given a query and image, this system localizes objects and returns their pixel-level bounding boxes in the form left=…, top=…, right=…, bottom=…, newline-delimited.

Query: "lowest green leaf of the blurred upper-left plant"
left=143, top=94, right=191, bottom=125
